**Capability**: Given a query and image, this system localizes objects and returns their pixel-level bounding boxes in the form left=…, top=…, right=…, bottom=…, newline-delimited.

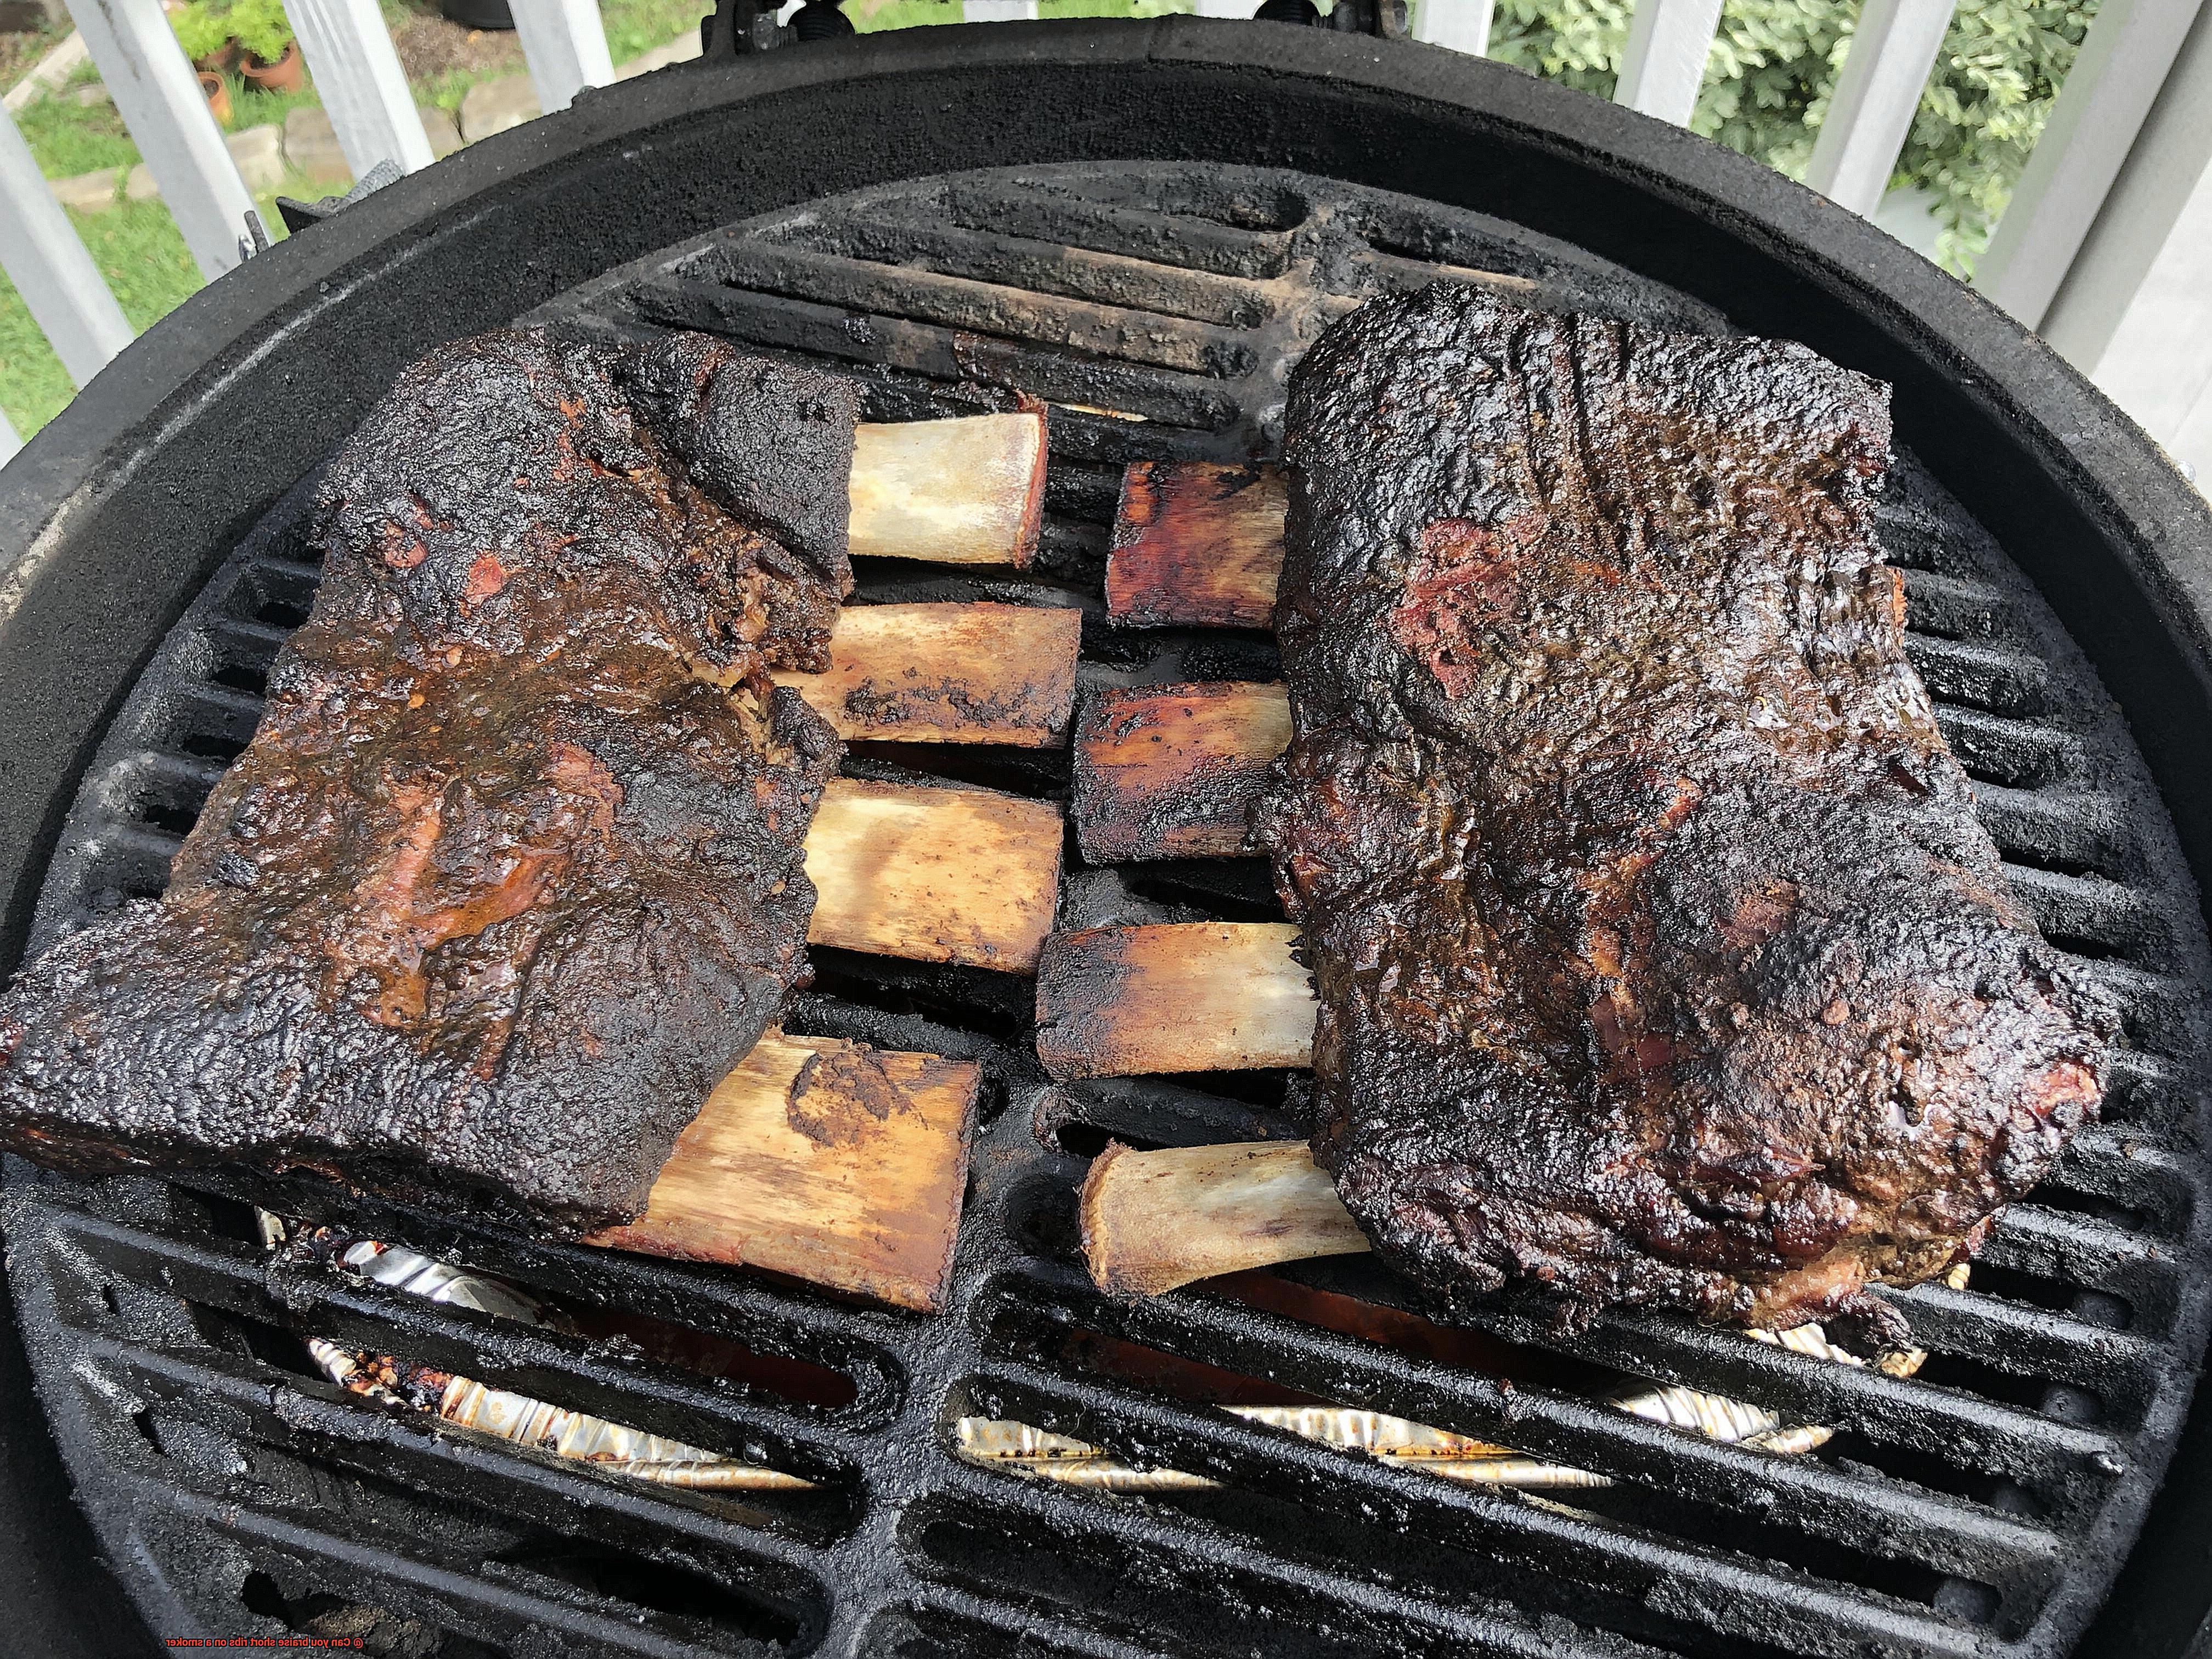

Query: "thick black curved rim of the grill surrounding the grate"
left=0, top=20, right=2212, bottom=1659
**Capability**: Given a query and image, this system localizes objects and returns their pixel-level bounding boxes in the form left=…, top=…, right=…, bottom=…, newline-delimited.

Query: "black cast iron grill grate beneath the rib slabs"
left=9, top=166, right=2212, bottom=1659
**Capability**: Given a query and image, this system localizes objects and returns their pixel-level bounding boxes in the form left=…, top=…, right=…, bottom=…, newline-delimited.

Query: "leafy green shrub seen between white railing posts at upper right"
left=1491, top=0, right=2095, bottom=272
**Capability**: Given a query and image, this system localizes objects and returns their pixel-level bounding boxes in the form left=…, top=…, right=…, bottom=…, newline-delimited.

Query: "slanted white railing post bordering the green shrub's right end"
left=1973, top=0, right=2197, bottom=328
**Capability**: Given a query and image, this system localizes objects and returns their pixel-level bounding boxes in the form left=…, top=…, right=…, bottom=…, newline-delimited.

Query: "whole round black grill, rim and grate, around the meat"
left=0, top=20, right=2212, bottom=1659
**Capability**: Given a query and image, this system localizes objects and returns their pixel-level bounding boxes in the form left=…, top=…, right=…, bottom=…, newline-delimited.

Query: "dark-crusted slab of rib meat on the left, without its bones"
left=0, top=332, right=858, bottom=1230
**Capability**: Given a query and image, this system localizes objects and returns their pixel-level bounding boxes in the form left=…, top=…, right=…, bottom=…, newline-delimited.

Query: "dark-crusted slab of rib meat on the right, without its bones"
left=1254, top=285, right=2115, bottom=1327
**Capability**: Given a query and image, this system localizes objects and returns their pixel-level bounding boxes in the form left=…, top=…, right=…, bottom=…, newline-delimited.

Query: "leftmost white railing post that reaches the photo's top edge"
left=69, top=0, right=255, bottom=281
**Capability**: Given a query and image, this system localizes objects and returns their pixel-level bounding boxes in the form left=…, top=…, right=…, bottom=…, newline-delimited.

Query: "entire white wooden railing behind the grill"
left=0, top=0, right=2212, bottom=478
